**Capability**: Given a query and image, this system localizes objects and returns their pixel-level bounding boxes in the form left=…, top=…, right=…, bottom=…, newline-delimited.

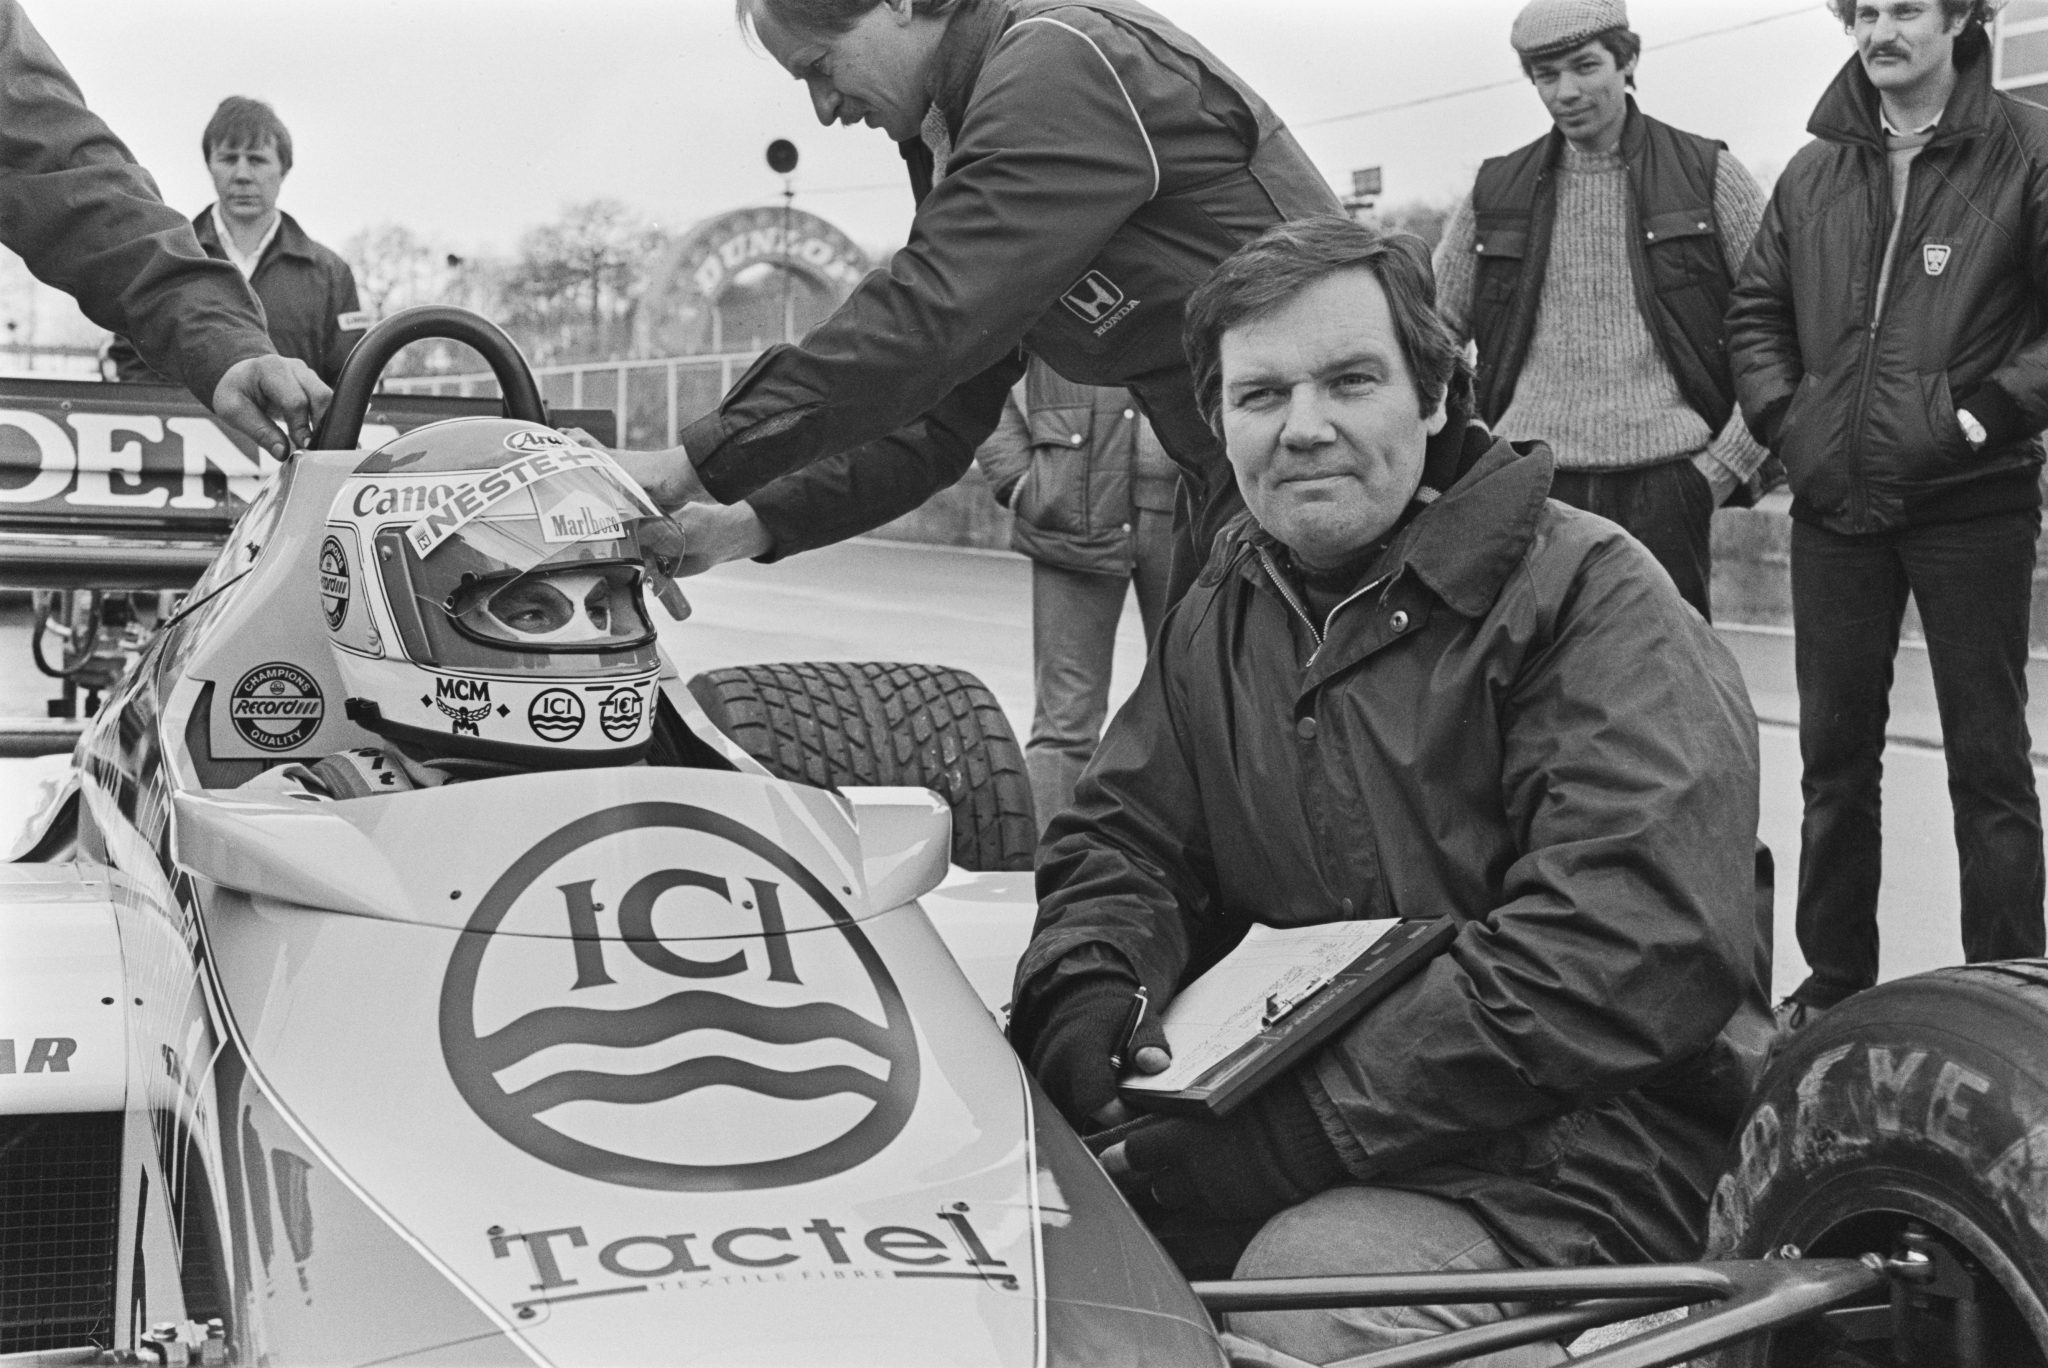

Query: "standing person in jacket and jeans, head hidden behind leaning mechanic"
left=975, top=358, right=1178, bottom=829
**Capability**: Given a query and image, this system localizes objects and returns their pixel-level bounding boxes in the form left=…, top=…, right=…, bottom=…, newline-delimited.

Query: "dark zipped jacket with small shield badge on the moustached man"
left=1729, top=25, right=2048, bottom=535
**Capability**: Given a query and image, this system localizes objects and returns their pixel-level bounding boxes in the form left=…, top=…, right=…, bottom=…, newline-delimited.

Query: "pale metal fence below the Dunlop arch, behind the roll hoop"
left=383, top=352, right=758, bottom=448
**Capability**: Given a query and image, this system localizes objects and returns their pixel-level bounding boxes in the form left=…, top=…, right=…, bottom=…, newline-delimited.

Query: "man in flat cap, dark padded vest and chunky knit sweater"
left=1436, top=0, right=1765, bottom=614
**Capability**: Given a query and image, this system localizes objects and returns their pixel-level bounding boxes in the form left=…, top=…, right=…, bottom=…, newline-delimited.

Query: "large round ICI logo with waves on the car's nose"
left=440, top=803, right=918, bottom=1192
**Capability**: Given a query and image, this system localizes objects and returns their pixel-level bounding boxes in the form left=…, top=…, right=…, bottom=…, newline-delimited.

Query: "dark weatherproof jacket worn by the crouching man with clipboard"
left=1016, top=424, right=1769, bottom=1264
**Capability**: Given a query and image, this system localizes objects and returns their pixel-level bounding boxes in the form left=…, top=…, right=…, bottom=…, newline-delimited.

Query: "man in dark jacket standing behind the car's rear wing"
left=109, top=94, right=371, bottom=385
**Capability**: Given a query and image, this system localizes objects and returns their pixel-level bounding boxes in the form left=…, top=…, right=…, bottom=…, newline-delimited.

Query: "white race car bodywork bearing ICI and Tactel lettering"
left=0, top=453, right=1221, bottom=1366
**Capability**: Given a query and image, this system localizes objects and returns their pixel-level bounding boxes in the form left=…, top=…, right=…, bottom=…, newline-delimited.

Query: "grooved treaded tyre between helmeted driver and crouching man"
left=690, top=661, right=1038, bottom=870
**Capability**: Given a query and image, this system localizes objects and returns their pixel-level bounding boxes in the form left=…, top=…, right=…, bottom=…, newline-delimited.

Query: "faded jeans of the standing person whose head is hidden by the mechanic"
left=1024, top=508, right=1174, bottom=829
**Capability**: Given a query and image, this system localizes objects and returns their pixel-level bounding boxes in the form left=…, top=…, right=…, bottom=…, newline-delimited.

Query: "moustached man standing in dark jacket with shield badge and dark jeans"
left=1729, top=0, right=2048, bottom=1034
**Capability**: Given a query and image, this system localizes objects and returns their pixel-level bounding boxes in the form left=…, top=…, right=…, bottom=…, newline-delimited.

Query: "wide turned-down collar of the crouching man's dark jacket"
left=1219, top=422, right=1552, bottom=618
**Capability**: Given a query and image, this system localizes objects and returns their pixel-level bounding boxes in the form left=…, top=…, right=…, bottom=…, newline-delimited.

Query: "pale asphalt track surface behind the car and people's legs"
left=0, top=541, right=2048, bottom=993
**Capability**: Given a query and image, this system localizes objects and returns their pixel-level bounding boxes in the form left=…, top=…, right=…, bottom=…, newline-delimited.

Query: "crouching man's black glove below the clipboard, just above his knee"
left=1124, top=1075, right=1348, bottom=1221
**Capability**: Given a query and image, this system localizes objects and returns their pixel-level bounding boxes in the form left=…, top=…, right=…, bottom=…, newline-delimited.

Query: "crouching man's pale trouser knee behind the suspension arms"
left=1229, top=1186, right=1565, bottom=1368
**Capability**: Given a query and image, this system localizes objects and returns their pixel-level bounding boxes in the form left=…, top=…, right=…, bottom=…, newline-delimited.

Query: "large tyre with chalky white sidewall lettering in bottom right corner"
left=1708, top=960, right=2048, bottom=1368
